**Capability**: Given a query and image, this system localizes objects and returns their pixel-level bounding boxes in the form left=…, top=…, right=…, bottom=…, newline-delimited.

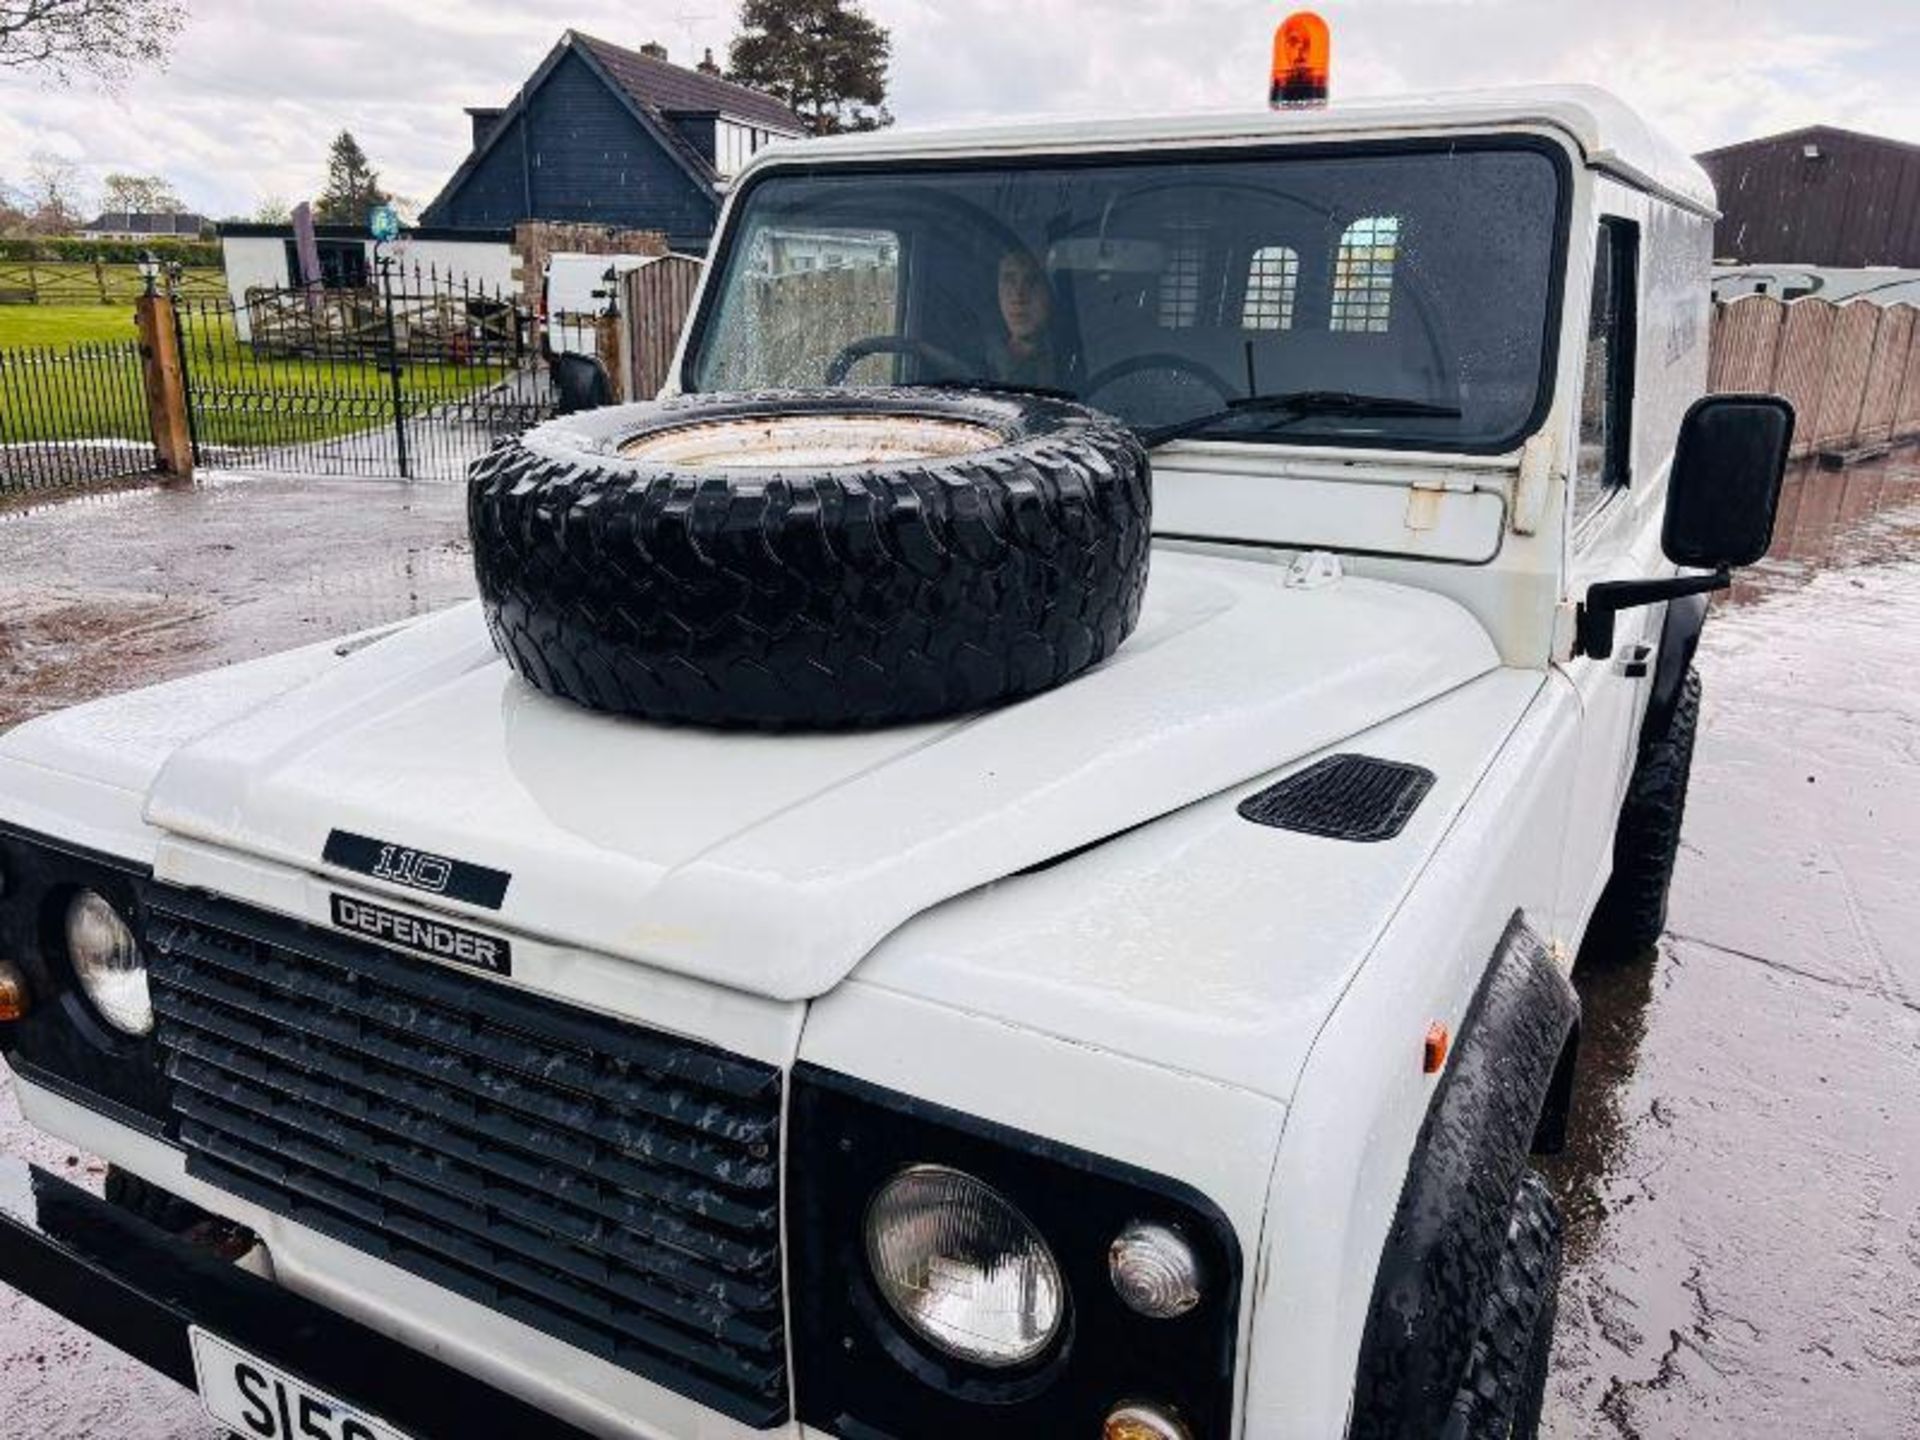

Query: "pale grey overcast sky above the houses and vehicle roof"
left=0, top=0, right=1920, bottom=215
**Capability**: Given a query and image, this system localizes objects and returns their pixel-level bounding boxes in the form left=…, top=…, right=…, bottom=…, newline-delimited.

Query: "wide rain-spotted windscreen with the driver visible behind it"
left=684, top=142, right=1561, bottom=449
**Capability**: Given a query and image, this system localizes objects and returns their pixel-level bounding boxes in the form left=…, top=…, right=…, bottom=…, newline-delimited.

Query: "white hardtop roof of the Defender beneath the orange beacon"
left=735, top=84, right=1715, bottom=217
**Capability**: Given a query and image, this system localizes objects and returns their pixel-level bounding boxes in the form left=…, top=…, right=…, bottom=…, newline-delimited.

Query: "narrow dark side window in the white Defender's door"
left=1572, top=219, right=1640, bottom=524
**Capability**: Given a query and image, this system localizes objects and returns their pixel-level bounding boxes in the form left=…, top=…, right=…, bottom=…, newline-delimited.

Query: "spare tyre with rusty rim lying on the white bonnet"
left=468, top=388, right=1150, bottom=728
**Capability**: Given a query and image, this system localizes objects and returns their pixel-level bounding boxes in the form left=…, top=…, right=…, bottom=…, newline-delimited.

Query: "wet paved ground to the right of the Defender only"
left=1546, top=451, right=1920, bottom=1440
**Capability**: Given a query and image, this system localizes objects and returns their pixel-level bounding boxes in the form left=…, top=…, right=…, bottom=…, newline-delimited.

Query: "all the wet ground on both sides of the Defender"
left=0, top=451, right=1920, bottom=1440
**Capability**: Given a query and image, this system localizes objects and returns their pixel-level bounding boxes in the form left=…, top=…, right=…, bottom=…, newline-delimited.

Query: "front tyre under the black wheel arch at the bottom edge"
left=1442, top=1169, right=1563, bottom=1440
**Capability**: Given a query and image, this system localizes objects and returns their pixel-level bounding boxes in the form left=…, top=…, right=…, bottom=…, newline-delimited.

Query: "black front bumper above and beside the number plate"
left=0, top=1156, right=588, bottom=1440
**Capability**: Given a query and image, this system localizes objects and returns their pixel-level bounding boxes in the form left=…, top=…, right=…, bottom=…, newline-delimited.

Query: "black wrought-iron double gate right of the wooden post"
left=175, top=263, right=553, bottom=480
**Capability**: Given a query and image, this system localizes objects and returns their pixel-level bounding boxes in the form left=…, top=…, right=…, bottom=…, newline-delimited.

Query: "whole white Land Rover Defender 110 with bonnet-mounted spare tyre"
left=0, top=90, right=1791, bottom=1440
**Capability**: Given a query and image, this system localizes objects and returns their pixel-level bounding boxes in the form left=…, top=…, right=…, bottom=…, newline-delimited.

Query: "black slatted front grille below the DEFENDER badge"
left=150, top=891, right=787, bottom=1427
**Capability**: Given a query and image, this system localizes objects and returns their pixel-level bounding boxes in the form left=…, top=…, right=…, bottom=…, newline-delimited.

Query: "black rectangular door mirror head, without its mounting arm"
left=1661, top=396, right=1793, bottom=570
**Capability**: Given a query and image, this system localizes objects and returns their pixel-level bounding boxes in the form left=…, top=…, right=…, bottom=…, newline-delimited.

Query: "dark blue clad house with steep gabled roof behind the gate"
left=420, top=31, right=804, bottom=253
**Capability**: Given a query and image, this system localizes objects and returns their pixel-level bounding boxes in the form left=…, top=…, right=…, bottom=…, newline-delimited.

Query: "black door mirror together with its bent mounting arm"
left=1574, top=396, right=1793, bottom=660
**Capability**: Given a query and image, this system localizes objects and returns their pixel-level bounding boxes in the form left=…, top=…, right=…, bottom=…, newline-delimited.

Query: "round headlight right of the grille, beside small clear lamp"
left=866, top=1165, right=1066, bottom=1367
